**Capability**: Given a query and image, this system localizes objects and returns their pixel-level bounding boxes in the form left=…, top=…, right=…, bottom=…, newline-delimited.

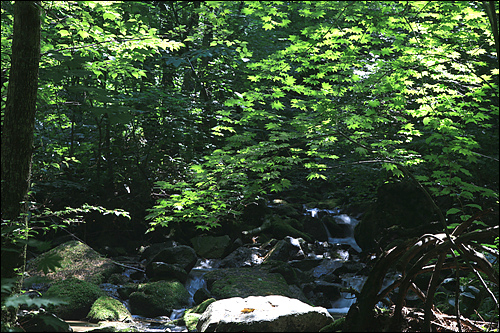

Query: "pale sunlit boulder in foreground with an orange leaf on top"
left=197, top=295, right=333, bottom=332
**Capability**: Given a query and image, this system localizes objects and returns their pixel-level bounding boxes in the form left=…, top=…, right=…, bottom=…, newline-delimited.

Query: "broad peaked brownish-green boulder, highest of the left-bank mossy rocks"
left=26, top=240, right=120, bottom=287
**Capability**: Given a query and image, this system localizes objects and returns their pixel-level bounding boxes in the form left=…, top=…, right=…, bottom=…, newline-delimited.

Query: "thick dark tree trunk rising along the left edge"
left=1, top=1, right=40, bottom=300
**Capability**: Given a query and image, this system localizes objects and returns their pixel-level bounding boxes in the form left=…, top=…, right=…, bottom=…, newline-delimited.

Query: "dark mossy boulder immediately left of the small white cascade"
left=130, top=281, right=190, bottom=317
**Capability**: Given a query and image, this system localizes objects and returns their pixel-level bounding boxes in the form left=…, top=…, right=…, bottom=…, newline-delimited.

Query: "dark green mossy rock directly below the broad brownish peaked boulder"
left=44, top=278, right=106, bottom=319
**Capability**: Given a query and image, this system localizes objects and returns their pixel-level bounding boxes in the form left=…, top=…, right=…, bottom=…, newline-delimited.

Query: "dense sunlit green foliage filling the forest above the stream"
left=1, top=1, right=499, bottom=326
